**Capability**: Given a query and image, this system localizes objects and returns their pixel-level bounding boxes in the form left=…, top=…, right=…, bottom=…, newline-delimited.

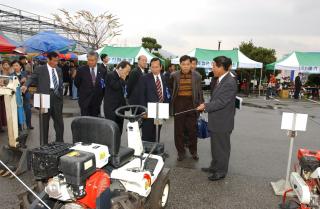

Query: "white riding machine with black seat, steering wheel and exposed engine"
left=21, top=105, right=170, bottom=209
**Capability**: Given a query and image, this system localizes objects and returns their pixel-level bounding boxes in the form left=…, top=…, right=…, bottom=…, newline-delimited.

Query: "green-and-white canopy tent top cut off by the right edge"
left=266, top=52, right=320, bottom=74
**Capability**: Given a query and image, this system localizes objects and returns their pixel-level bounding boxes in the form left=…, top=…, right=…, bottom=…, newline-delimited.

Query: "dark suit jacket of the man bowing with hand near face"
left=104, top=70, right=126, bottom=121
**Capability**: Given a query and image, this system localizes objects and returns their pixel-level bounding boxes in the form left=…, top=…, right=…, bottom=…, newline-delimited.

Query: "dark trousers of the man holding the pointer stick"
left=210, top=132, right=231, bottom=175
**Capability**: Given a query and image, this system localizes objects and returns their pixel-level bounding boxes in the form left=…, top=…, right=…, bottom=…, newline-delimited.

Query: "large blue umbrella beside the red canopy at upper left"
left=22, top=31, right=76, bottom=53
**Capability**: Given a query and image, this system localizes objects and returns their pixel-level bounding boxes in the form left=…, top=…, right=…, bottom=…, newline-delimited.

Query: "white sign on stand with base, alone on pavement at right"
left=271, top=112, right=308, bottom=196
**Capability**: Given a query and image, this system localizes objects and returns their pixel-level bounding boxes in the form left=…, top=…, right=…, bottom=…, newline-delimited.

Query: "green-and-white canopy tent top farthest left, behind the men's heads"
left=78, top=46, right=163, bottom=64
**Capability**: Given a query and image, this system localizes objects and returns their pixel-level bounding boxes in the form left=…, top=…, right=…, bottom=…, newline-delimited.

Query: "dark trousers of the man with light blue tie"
left=42, top=91, right=64, bottom=144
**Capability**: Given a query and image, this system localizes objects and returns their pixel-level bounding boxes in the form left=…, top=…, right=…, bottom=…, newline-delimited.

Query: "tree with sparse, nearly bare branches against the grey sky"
left=53, top=9, right=121, bottom=49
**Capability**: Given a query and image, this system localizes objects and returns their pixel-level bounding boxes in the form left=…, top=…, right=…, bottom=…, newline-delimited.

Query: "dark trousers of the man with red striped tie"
left=141, top=118, right=161, bottom=142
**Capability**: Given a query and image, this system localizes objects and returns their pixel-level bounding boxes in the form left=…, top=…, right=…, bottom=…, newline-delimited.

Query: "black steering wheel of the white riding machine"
left=115, top=105, right=148, bottom=122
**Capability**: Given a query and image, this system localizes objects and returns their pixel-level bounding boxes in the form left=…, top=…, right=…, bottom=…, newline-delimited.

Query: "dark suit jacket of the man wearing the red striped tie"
left=139, top=73, right=171, bottom=107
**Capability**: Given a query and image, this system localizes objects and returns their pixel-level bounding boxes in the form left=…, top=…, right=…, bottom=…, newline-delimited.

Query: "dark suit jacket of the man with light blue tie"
left=25, top=65, right=63, bottom=100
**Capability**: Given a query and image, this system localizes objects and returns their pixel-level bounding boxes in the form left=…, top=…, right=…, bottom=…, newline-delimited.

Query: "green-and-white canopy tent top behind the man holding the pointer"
left=171, top=48, right=263, bottom=69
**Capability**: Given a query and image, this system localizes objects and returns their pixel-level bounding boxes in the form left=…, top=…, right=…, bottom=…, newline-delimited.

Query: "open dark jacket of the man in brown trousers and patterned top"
left=170, top=71, right=204, bottom=108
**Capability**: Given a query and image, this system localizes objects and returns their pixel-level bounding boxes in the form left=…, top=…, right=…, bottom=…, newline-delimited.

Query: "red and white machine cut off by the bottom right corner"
left=280, top=149, right=320, bottom=209
